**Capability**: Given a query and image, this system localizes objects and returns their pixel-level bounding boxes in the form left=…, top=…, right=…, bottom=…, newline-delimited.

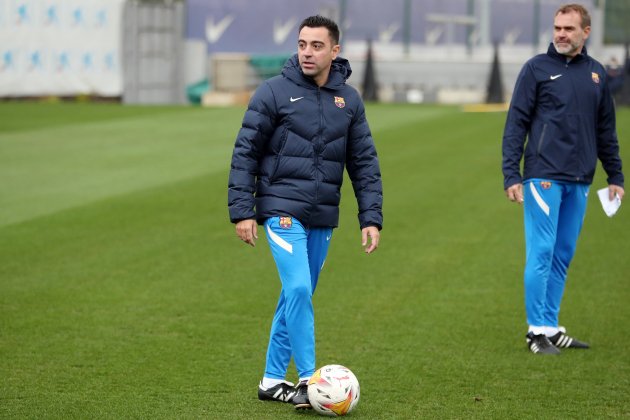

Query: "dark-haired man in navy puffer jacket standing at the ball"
left=228, top=16, right=383, bottom=408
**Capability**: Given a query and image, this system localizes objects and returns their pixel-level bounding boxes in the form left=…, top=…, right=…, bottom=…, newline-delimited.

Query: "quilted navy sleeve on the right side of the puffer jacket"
left=346, top=101, right=383, bottom=230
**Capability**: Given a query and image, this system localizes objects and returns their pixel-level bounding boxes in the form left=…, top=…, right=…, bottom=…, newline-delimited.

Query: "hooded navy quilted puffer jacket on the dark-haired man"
left=228, top=54, right=383, bottom=229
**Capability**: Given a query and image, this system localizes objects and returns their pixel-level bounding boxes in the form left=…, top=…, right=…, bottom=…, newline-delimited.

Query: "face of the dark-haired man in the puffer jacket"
left=298, top=26, right=340, bottom=86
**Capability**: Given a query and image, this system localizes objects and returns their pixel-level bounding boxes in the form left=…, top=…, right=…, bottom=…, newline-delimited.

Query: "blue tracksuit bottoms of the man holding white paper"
left=523, top=179, right=589, bottom=328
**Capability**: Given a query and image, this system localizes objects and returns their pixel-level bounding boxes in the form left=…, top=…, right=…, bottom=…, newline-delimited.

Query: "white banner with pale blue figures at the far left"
left=0, top=0, right=125, bottom=97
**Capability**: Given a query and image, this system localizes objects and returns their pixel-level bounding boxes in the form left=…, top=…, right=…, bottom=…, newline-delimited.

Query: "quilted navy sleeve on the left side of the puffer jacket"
left=228, top=83, right=276, bottom=223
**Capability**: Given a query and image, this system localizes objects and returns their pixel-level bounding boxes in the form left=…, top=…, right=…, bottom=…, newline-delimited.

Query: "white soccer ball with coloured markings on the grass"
left=308, top=365, right=360, bottom=417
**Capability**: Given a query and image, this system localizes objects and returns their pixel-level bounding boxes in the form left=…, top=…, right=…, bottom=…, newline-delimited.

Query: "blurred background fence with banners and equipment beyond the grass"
left=0, top=0, right=630, bottom=105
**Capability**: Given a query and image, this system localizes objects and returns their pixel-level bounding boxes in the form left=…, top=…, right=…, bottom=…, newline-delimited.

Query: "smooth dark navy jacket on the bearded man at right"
left=503, top=44, right=624, bottom=189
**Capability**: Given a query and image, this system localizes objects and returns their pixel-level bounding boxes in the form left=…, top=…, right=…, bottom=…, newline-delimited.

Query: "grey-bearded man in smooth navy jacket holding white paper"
left=503, top=4, right=624, bottom=354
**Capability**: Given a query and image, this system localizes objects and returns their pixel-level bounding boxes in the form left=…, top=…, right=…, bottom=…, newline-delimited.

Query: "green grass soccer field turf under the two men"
left=0, top=103, right=630, bottom=419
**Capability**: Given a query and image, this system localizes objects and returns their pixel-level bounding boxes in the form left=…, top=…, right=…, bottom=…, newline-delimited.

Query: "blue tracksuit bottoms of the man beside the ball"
left=264, top=217, right=332, bottom=379
